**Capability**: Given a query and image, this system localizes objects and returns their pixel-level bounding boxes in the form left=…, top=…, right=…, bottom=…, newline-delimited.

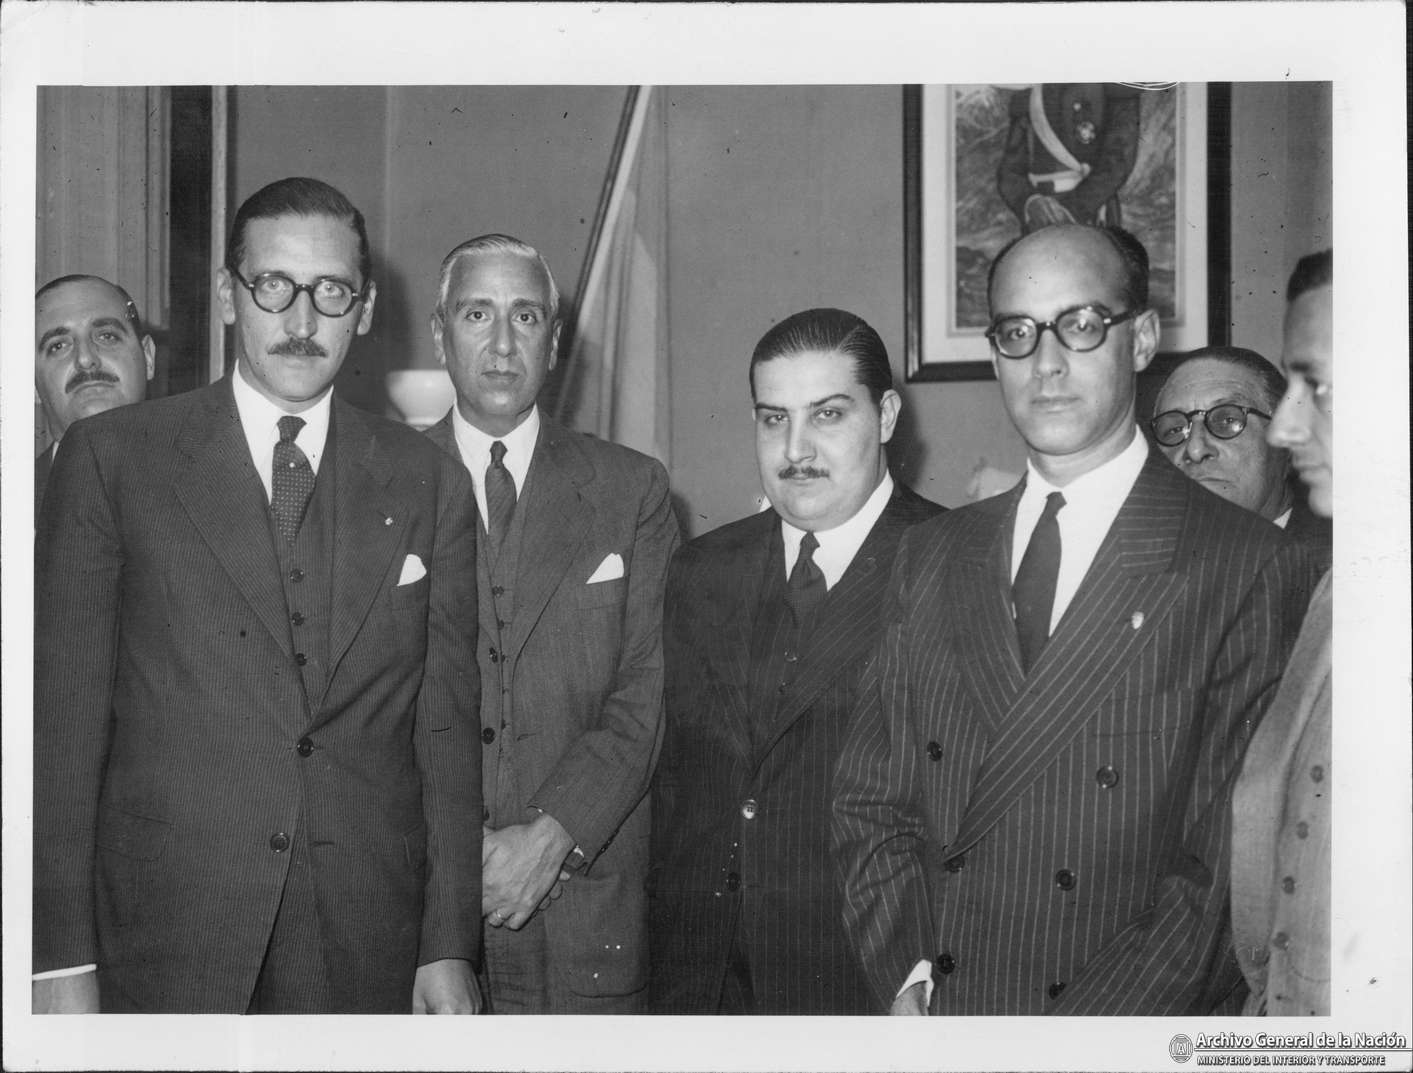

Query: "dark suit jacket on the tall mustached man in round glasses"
left=34, top=380, right=480, bottom=1012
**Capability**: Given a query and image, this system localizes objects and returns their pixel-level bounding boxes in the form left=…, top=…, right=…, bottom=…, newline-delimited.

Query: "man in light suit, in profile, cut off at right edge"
left=1232, top=250, right=1334, bottom=1016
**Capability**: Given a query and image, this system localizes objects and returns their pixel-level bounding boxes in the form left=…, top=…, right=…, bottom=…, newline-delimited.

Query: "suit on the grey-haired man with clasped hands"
left=427, top=414, right=678, bottom=1014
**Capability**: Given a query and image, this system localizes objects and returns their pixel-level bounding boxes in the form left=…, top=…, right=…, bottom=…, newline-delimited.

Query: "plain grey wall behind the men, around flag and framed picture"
left=232, top=83, right=1330, bottom=534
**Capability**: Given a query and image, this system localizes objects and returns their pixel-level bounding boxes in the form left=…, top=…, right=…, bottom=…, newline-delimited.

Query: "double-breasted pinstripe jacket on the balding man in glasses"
left=835, top=451, right=1306, bottom=1014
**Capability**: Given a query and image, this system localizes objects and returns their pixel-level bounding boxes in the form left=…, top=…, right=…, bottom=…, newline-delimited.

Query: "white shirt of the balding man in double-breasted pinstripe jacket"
left=897, top=426, right=1149, bottom=1005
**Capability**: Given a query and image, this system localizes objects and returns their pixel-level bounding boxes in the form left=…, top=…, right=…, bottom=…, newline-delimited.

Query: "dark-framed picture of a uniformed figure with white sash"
left=903, top=82, right=1231, bottom=380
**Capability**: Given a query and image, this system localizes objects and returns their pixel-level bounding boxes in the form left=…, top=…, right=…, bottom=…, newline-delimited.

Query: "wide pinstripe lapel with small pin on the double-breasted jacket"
left=948, top=452, right=1190, bottom=854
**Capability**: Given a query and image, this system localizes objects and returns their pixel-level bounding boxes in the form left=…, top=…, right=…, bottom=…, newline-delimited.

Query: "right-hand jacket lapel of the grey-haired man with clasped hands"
left=506, top=417, right=593, bottom=659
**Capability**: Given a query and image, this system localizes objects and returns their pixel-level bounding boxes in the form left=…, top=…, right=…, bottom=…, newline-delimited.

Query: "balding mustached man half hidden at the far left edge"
left=34, top=276, right=157, bottom=516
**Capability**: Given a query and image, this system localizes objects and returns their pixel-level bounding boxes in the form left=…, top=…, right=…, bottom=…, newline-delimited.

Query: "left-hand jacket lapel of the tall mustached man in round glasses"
left=175, top=379, right=294, bottom=657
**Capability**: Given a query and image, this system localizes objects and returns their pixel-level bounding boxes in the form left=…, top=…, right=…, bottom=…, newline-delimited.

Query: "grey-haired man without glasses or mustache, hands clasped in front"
left=428, top=235, right=678, bottom=1014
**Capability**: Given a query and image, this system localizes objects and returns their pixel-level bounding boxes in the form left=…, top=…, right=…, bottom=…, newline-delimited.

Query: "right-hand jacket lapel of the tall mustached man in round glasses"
left=329, top=399, right=407, bottom=683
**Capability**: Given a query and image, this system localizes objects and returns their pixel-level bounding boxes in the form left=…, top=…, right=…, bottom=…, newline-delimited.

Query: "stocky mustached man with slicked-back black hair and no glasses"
left=651, top=310, right=941, bottom=1014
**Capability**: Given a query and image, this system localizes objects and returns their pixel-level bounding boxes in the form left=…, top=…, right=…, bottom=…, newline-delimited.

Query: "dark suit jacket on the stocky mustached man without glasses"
left=651, top=485, right=942, bottom=1014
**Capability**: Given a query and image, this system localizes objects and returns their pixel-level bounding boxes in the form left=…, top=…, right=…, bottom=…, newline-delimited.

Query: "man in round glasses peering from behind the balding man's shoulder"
left=1149, top=346, right=1331, bottom=573
